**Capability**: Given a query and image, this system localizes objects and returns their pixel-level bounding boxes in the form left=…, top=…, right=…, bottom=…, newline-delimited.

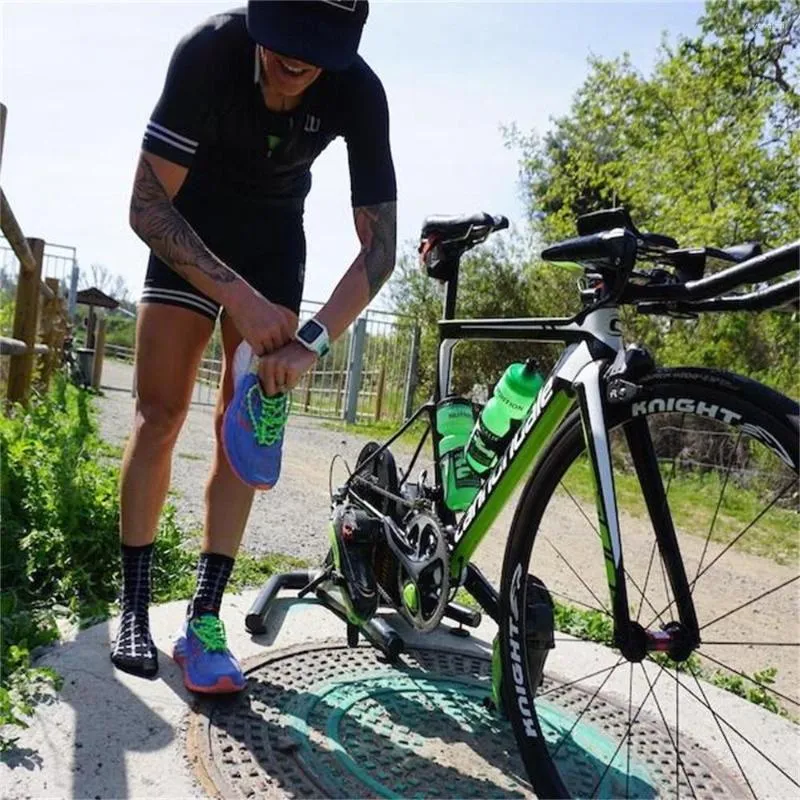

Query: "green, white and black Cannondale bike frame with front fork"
left=382, top=306, right=699, bottom=659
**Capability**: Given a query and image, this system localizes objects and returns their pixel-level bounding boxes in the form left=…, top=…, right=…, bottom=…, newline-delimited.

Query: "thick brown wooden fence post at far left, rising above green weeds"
left=8, top=234, right=44, bottom=404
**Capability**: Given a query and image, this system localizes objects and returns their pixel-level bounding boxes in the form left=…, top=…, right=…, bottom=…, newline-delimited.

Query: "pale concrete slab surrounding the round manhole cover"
left=0, top=591, right=800, bottom=799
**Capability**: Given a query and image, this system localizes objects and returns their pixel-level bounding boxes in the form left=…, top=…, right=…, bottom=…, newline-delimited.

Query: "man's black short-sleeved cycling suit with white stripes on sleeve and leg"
left=142, top=9, right=396, bottom=319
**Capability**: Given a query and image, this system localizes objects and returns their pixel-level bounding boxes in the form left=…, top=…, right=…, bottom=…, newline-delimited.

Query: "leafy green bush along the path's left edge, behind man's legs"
left=0, top=378, right=196, bottom=749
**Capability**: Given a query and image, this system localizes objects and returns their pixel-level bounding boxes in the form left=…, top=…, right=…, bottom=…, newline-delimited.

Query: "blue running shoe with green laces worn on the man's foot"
left=172, top=614, right=242, bottom=694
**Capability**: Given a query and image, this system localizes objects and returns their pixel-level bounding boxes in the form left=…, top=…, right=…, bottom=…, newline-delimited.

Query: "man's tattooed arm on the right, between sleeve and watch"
left=317, top=202, right=397, bottom=340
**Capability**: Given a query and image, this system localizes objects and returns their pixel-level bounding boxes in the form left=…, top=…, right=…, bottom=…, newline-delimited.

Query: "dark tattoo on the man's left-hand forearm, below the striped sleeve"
left=131, top=158, right=237, bottom=283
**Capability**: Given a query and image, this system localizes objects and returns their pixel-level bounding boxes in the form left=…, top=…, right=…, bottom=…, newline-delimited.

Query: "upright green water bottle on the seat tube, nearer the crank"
left=436, top=397, right=481, bottom=511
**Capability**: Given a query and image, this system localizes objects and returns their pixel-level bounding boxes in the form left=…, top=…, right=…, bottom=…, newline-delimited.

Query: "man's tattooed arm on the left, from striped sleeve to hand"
left=130, top=153, right=297, bottom=353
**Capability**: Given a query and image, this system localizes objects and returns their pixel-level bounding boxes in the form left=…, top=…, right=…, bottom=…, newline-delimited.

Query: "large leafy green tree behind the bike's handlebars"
left=508, top=0, right=800, bottom=395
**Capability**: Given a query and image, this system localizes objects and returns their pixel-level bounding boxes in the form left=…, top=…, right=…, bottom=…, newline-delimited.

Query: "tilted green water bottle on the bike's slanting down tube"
left=465, top=359, right=544, bottom=475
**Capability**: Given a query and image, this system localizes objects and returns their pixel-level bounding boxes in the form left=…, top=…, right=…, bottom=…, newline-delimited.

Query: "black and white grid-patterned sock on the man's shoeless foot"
left=111, top=544, right=158, bottom=678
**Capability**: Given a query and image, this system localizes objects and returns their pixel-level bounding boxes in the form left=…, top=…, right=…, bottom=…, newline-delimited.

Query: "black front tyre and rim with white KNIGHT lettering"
left=499, top=368, right=800, bottom=798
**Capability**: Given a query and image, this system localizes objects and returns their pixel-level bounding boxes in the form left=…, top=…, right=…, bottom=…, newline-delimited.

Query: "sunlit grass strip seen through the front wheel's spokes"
left=563, top=457, right=800, bottom=564
